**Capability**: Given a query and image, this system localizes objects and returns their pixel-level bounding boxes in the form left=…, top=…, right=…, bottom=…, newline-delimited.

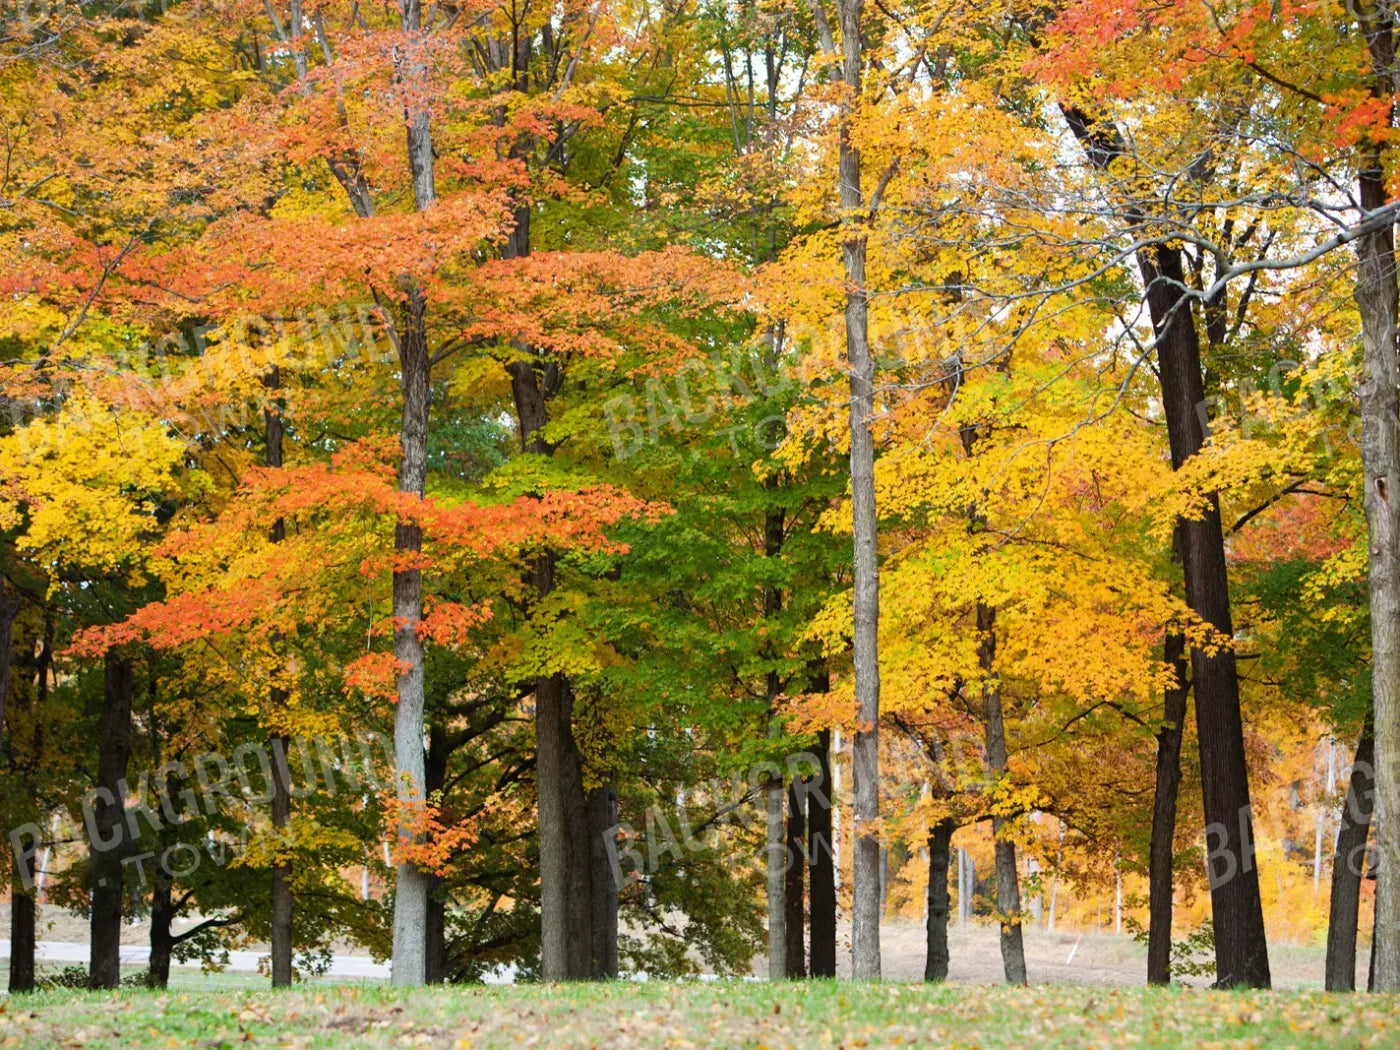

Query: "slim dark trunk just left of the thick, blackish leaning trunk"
left=1148, top=631, right=1190, bottom=984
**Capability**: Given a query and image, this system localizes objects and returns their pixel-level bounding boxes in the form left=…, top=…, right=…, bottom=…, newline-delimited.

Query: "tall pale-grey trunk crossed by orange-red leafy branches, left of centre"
left=393, top=0, right=437, bottom=986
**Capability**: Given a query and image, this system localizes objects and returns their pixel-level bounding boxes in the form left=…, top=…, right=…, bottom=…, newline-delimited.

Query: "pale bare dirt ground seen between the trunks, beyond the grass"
left=0, top=907, right=1368, bottom=988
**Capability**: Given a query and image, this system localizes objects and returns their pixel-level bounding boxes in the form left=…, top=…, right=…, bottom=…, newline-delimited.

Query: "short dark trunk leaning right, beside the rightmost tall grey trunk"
left=1324, top=714, right=1375, bottom=991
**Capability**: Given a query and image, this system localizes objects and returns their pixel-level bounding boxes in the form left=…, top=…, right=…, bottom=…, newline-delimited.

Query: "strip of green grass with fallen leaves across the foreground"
left=0, top=981, right=1400, bottom=1050
